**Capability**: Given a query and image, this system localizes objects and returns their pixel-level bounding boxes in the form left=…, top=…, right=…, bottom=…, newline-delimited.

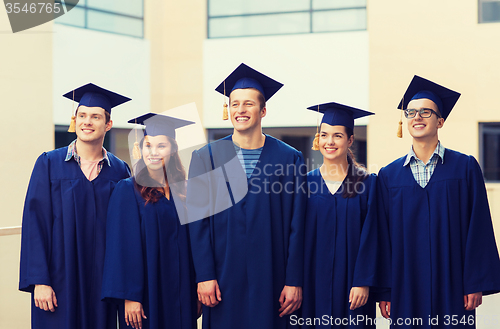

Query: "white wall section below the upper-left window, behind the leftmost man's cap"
left=52, top=24, right=151, bottom=129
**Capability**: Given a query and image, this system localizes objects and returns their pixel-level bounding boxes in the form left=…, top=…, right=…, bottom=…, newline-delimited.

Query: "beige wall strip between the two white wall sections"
left=145, top=0, right=206, bottom=120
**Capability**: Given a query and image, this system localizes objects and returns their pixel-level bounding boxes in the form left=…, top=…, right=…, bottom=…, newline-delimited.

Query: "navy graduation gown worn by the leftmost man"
left=19, top=147, right=130, bottom=329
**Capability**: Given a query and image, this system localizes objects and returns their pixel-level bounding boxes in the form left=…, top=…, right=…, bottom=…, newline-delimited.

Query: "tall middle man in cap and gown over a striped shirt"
left=187, top=64, right=306, bottom=329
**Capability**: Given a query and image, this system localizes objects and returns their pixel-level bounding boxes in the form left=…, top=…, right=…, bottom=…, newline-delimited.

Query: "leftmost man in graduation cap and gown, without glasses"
left=19, top=84, right=130, bottom=329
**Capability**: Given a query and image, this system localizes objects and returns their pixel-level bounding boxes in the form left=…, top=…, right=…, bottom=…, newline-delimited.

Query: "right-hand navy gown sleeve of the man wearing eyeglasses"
left=464, top=156, right=500, bottom=295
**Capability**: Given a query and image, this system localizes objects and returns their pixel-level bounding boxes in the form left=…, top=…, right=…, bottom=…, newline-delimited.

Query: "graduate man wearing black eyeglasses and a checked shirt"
left=377, top=76, right=500, bottom=328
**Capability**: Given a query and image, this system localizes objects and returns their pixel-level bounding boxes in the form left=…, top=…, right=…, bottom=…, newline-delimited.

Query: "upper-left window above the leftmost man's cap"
left=55, top=0, right=144, bottom=38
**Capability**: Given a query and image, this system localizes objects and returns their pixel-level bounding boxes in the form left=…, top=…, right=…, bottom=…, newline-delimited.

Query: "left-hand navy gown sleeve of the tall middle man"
left=186, top=151, right=217, bottom=282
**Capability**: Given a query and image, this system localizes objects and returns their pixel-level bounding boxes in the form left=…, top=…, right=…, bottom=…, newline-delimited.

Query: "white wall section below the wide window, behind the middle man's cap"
left=203, top=31, right=369, bottom=128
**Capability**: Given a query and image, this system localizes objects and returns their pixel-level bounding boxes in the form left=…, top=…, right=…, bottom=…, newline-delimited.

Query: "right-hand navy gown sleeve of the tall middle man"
left=285, top=153, right=307, bottom=287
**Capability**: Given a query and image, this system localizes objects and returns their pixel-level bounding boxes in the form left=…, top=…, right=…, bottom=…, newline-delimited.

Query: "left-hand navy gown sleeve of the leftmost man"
left=19, top=153, right=53, bottom=292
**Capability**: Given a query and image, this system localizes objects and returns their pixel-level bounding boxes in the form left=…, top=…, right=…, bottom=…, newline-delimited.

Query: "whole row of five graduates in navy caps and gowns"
left=19, top=64, right=500, bottom=329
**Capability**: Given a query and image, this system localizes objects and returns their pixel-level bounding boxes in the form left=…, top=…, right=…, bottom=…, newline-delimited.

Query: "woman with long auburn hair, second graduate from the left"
left=102, top=113, right=201, bottom=329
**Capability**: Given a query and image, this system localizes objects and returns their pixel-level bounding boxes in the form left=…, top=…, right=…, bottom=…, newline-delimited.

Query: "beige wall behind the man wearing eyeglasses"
left=368, top=0, right=500, bottom=328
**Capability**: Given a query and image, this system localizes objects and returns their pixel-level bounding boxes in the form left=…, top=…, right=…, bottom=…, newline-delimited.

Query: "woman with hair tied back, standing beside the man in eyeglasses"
left=302, top=103, right=386, bottom=328
